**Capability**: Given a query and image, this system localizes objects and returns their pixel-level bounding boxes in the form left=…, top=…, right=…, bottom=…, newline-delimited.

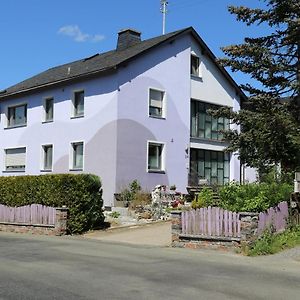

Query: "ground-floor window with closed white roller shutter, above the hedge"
left=5, top=147, right=26, bottom=171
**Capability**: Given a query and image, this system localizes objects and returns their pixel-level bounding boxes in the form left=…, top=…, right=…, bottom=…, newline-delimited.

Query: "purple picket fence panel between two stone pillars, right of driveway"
left=181, top=207, right=241, bottom=238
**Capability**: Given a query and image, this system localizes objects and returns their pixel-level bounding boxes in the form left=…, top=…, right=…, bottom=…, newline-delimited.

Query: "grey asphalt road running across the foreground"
left=0, top=232, right=300, bottom=300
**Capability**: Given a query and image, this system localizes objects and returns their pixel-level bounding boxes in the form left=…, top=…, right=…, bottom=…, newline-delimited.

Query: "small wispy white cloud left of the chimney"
left=57, top=25, right=104, bottom=43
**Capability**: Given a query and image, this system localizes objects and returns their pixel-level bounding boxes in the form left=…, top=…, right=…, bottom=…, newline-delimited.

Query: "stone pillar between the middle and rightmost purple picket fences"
left=240, top=212, right=259, bottom=243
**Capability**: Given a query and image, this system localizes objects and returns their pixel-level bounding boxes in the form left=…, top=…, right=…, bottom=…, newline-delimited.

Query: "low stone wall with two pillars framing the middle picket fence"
left=171, top=211, right=258, bottom=250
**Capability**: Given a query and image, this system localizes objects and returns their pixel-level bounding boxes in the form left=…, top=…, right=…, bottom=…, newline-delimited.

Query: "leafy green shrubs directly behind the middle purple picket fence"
left=219, top=182, right=293, bottom=212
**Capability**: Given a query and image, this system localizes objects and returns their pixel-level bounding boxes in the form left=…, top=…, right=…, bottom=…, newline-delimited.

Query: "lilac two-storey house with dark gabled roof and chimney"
left=0, top=28, right=255, bottom=206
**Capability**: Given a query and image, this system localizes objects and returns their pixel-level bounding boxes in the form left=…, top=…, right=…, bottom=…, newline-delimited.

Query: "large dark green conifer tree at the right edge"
left=212, top=0, right=300, bottom=172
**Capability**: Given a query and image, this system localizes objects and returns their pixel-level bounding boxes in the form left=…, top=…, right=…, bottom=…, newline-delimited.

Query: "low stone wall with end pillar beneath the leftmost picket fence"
left=0, top=207, right=68, bottom=235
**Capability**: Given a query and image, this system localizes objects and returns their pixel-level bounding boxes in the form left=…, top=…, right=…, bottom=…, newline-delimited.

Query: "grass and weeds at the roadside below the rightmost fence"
left=245, top=226, right=300, bottom=256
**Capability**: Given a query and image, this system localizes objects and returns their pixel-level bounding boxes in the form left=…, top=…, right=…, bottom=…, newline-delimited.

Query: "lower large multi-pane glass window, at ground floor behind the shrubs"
left=190, top=149, right=229, bottom=185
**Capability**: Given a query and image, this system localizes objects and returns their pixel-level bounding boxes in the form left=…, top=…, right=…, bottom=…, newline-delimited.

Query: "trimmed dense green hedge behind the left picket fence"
left=0, top=174, right=104, bottom=233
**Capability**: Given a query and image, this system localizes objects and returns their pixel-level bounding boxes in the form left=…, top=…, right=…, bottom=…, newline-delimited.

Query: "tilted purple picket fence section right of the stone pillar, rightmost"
left=258, top=202, right=289, bottom=234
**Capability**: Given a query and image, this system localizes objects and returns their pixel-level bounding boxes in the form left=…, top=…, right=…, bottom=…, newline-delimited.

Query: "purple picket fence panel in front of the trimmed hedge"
left=0, top=204, right=56, bottom=225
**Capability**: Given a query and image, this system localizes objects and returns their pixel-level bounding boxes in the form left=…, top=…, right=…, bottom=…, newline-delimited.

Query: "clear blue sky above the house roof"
left=0, top=0, right=263, bottom=90
